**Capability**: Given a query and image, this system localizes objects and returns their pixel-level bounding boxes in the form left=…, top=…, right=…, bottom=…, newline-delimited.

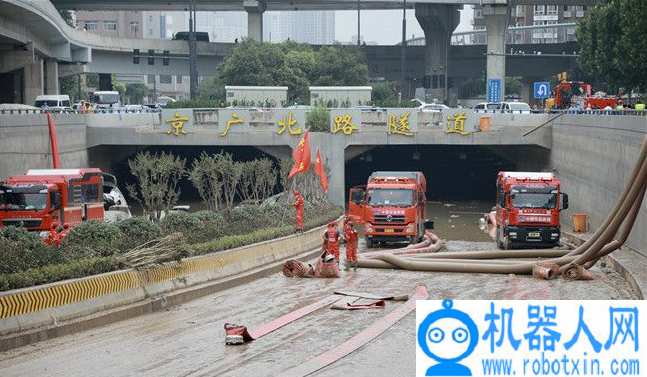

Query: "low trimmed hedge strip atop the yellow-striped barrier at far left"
left=0, top=257, right=117, bottom=291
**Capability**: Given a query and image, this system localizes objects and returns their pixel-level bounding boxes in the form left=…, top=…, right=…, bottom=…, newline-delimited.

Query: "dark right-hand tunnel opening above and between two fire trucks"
left=345, top=145, right=548, bottom=202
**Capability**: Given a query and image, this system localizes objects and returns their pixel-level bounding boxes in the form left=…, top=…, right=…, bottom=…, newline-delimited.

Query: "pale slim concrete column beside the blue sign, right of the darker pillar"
left=483, top=5, right=508, bottom=101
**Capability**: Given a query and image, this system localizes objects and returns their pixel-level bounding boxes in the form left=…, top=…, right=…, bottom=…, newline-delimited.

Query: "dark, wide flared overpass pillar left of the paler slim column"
left=416, top=4, right=460, bottom=102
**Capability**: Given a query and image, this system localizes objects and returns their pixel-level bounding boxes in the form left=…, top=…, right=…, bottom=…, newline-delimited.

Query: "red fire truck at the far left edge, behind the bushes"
left=0, top=168, right=104, bottom=242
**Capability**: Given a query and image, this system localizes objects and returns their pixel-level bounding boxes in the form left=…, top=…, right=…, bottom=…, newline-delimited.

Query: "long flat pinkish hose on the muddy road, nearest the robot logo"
left=281, top=285, right=429, bottom=376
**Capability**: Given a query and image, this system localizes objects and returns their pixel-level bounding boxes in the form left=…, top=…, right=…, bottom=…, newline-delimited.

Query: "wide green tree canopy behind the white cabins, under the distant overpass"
left=213, top=39, right=369, bottom=103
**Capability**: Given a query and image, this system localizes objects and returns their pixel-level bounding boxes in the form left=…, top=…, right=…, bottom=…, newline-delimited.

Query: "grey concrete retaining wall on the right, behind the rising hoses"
left=549, top=115, right=647, bottom=256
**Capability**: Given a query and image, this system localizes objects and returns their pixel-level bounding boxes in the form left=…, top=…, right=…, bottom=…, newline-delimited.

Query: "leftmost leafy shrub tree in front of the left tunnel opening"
left=126, top=152, right=186, bottom=220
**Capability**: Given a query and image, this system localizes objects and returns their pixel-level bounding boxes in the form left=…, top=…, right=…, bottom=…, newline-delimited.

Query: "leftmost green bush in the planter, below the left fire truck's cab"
left=0, top=226, right=63, bottom=274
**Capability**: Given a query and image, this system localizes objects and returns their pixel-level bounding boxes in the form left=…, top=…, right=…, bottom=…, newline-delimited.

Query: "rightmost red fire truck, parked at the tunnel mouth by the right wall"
left=496, top=171, right=568, bottom=249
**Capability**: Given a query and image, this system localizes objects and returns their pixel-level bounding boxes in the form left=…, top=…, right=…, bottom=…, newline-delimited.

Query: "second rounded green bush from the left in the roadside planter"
left=59, top=220, right=123, bottom=262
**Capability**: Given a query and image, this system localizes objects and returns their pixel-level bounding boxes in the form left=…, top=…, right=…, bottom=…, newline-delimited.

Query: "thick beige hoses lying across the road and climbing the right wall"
left=358, top=137, right=647, bottom=280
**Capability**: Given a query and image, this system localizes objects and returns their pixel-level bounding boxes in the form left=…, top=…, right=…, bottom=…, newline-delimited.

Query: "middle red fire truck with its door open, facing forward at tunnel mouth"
left=348, top=171, right=433, bottom=247
